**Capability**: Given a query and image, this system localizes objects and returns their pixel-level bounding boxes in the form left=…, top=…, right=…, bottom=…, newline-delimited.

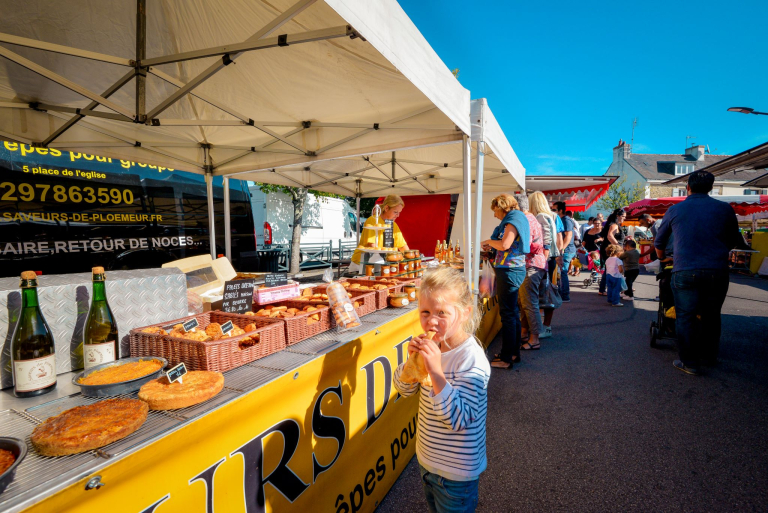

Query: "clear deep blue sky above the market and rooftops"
left=399, top=0, right=768, bottom=174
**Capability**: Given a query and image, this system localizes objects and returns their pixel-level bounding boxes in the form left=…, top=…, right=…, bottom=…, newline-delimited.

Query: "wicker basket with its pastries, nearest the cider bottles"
left=130, top=310, right=286, bottom=372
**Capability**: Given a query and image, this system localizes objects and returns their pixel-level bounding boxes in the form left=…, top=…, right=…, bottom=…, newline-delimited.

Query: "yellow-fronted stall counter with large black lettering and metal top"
left=0, top=305, right=421, bottom=513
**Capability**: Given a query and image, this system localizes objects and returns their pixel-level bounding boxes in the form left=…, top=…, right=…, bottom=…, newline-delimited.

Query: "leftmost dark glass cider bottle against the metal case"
left=11, top=271, right=56, bottom=397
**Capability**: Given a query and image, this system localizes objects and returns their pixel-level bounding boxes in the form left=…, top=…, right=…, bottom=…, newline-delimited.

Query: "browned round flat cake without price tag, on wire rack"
left=30, top=396, right=149, bottom=456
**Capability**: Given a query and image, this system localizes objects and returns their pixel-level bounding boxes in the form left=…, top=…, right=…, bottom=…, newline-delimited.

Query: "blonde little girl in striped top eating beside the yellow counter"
left=393, top=267, right=491, bottom=513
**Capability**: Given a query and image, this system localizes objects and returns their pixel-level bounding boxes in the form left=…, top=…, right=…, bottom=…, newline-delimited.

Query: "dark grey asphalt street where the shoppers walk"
left=379, top=275, right=768, bottom=513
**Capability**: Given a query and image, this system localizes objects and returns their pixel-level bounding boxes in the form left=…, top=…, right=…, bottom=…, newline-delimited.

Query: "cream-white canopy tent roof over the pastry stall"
left=0, top=0, right=524, bottom=288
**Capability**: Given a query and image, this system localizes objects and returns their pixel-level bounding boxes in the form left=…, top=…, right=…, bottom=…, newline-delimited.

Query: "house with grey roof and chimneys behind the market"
left=585, top=141, right=766, bottom=215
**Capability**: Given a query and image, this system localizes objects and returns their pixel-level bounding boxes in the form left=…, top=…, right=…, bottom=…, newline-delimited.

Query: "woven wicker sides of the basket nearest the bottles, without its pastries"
left=130, top=311, right=285, bottom=372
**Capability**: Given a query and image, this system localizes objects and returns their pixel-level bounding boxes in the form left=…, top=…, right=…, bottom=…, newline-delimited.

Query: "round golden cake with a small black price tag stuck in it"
left=139, top=371, right=224, bottom=410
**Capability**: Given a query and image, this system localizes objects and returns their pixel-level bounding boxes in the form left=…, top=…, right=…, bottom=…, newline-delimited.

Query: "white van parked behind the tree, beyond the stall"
left=248, top=185, right=355, bottom=248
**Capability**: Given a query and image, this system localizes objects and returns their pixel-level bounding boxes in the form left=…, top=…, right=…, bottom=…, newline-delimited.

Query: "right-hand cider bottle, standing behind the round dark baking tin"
left=83, top=267, right=120, bottom=370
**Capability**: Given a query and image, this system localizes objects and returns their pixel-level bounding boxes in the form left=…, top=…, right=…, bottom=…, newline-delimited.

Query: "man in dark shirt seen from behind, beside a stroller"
left=653, top=171, right=744, bottom=374
